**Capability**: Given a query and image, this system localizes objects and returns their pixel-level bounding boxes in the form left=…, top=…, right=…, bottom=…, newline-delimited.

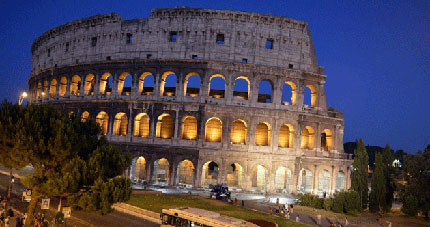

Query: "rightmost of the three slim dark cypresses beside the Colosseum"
left=382, top=144, right=396, bottom=212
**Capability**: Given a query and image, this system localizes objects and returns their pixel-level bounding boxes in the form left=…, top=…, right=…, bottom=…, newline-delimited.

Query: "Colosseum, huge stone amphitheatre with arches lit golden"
left=28, top=7, right=352, bottom=195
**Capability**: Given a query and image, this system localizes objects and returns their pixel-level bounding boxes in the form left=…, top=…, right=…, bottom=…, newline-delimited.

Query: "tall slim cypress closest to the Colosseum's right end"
left=351, top=138, right=369, bottom=209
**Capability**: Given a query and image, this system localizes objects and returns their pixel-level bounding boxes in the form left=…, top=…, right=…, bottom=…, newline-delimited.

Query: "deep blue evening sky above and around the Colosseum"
left=0, top=0, right=430, bottom=153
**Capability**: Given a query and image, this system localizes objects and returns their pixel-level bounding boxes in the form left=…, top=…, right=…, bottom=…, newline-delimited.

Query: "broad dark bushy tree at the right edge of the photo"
left=400, top=145, right=430, bottom=220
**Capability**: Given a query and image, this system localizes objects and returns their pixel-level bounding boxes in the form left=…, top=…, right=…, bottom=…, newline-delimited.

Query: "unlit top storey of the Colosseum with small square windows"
left=31, top=7, right=323, bottom=74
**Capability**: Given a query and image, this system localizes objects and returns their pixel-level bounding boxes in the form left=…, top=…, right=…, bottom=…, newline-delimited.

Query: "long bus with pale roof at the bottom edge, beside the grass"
left=160, top=207, right=258, bottom=227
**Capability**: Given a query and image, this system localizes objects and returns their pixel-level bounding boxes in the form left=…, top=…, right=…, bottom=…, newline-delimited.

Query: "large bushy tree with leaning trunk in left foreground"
left=13, top=105, right=131, bottom=226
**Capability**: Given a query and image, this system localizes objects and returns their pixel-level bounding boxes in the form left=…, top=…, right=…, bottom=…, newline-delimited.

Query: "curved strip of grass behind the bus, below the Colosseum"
left=127, top=194, right=307, bottom=226
